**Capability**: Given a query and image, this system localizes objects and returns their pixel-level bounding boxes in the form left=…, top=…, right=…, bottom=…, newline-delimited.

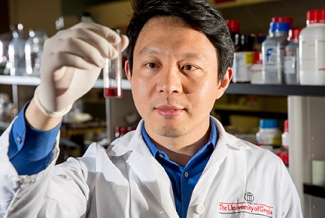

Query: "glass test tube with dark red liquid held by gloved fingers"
left=103, top=29, right=123, bottom=98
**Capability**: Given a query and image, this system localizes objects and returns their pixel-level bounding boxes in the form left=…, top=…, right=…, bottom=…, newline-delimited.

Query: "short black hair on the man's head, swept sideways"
left=126, top=0, right=234, bottom=80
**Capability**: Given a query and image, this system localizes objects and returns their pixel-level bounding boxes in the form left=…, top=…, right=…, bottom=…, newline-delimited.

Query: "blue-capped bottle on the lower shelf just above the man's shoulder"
left=256, top=119, right=282, bottom=153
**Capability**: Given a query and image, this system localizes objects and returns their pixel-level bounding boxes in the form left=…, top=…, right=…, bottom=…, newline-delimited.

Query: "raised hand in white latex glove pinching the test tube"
left=34, top=22, right=129, bottom=117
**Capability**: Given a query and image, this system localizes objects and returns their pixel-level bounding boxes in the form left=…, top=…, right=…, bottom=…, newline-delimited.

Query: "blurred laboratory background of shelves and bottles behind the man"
left=0, top=0, right=325, bottom=218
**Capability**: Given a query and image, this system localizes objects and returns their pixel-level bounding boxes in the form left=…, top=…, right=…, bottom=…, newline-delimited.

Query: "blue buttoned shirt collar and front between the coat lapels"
left=141, top=118, right=218, bottom=218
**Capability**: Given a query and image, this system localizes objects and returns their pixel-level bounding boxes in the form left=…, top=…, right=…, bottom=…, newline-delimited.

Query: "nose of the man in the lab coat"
left=157, top=66, right=183, bottom=94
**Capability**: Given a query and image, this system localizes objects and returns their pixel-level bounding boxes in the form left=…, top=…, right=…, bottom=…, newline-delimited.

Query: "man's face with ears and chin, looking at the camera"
left=126, top=17, right=231, bottom=143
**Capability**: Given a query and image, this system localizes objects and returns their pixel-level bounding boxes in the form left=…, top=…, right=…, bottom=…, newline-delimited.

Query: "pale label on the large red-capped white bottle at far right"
left=300, top=40, right=325, bottom=73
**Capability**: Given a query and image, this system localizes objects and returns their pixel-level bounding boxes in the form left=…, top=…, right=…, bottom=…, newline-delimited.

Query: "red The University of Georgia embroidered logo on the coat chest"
left=219, top=192, right=273, bottom=218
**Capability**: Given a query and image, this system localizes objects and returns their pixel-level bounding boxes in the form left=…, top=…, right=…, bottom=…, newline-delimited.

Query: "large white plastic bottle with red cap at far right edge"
left=299, top=9, right=325, bottom=85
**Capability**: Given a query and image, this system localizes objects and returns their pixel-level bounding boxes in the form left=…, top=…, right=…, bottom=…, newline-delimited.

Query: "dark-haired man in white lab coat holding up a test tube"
left=0, top=0, right=302, bottom=218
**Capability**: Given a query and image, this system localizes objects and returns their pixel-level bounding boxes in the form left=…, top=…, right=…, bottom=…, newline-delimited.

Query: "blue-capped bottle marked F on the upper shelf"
left=262, top=22, right=290, bottom=84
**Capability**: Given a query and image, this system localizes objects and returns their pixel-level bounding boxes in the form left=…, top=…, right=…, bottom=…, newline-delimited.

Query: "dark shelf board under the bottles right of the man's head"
left=225, top=83, right=325, bottom=96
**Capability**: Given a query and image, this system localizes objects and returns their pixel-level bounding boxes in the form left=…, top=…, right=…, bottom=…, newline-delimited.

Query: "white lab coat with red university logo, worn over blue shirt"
left=0, top=116, right=302, bottom=218
